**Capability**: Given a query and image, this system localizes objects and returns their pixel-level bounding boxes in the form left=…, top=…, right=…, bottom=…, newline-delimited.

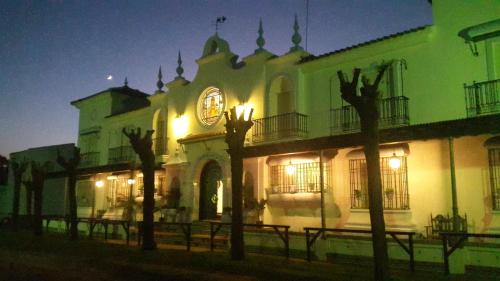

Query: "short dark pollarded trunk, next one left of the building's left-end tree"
left=31, top=161, right=51, bottom=236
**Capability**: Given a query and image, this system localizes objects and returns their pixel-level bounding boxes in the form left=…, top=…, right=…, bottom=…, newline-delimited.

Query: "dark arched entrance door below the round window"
left=199, top=161, right=222, bottom=220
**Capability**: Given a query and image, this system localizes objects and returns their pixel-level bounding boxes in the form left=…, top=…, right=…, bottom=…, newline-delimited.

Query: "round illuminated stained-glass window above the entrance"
left=198, top=87, right=224, bottom=126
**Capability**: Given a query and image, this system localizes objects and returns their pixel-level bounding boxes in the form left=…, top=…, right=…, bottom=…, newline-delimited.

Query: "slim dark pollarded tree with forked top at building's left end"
left=57, top=147, right=80, bottom=240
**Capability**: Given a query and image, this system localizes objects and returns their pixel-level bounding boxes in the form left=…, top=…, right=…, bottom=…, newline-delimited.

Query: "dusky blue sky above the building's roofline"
left=0, top=0, right=432, bottom=157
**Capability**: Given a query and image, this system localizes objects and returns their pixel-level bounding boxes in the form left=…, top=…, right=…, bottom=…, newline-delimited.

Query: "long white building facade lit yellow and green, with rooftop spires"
left=64, top=1, right=500, bottom=236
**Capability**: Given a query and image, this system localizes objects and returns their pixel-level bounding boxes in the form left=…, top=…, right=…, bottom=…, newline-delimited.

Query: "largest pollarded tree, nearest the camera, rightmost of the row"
left=337, top=64, right=390, bottom=281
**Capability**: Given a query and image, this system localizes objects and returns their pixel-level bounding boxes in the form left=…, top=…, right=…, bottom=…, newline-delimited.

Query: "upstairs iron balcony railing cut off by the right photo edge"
left=464, top=79, right=500, bottom=117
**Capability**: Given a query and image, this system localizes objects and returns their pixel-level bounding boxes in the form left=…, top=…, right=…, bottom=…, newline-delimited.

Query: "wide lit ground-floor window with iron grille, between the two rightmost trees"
left=269, top=162, right=330, bottom=193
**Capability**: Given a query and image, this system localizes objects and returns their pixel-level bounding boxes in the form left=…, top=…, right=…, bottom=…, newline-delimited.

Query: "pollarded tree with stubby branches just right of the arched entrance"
left=224, top=107, right=253, bottom=260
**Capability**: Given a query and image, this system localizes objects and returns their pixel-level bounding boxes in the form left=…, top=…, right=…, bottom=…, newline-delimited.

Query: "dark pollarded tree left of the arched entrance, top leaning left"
left=122, top=128, right=156, bottom=250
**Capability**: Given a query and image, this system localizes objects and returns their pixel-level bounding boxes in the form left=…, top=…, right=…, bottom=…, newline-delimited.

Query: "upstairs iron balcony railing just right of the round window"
left=252, top=112, right=307, bottom=143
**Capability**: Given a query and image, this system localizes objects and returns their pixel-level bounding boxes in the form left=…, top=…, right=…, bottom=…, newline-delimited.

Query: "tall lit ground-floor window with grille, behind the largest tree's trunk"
left=349, top=156, right=410, bottom=210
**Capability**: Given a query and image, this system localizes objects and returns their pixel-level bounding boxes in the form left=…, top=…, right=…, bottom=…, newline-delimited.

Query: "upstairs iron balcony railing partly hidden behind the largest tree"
left=330, top=96, right=410, bottom=133
